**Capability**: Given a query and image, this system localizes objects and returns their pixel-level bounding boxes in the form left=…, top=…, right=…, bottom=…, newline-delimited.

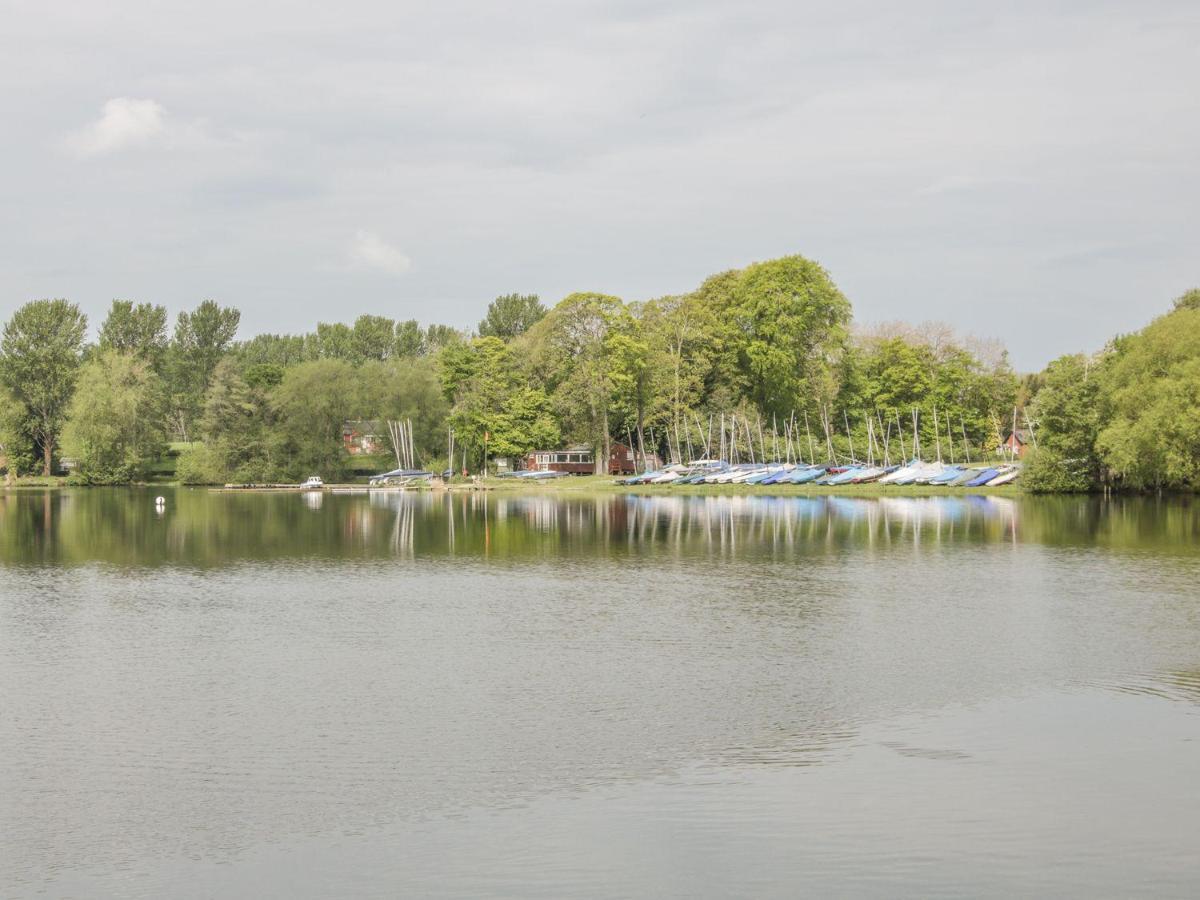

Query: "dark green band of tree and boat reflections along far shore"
left=0, top=490, right=1200, bottom=566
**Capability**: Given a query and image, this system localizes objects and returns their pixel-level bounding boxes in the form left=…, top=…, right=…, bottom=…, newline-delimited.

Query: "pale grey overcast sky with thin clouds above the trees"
left=0, top=0, right=1200, bottom=368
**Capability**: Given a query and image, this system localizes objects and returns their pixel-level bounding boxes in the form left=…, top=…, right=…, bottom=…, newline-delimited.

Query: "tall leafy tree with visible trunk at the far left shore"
left=0, top=300, right=88, bottom=475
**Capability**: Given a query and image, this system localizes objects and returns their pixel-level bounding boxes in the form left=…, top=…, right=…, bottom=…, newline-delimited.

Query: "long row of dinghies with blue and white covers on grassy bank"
left=619, top=460, right=1021, bottom=487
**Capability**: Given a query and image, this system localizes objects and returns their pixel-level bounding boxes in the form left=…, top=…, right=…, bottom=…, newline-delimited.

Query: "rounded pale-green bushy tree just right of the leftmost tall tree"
left=62, top=350, right=166, bottom=485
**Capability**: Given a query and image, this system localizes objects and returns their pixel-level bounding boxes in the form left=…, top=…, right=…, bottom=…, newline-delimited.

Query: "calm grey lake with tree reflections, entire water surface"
left=0, top=490, right=1200, bottom=898
